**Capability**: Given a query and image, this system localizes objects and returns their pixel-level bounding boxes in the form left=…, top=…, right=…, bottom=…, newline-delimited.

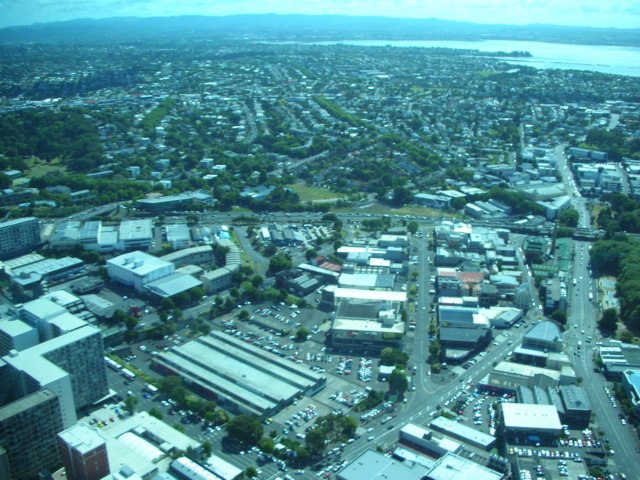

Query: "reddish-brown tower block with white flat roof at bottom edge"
left=58, top=423, right=110, bottom=480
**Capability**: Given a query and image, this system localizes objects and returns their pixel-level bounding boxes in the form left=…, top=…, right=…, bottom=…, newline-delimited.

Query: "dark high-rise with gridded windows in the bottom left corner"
left=0, top=389, right=63, bottom=480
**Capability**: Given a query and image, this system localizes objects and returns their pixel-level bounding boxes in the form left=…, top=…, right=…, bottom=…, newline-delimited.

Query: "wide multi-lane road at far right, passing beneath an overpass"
left=556, top=146, right=640, bottom=478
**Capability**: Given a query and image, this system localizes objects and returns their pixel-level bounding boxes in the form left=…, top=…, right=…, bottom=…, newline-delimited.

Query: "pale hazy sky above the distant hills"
left=0, top=0, right=640, bottom=28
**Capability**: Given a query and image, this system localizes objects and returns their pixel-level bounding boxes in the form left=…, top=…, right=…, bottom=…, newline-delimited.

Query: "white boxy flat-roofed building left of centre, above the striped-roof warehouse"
left=107, top=251, right=175, bottom=292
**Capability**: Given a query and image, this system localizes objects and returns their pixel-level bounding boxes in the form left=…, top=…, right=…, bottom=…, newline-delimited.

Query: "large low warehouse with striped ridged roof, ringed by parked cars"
left=153, top=332, right=326, bottom=418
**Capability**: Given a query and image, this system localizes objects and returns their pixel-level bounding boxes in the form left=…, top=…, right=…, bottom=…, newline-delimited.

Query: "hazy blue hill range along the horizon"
left=0, top=14, right=640, bottom=47
